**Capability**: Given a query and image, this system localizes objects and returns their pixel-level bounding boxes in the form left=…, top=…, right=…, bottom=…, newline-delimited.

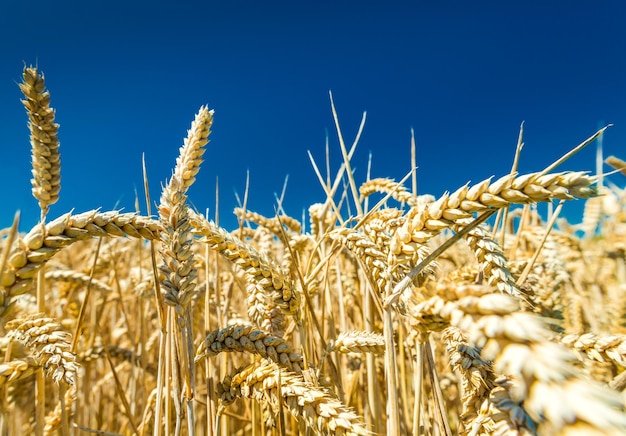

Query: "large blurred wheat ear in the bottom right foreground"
left=411, top=293, right=626, bottom=434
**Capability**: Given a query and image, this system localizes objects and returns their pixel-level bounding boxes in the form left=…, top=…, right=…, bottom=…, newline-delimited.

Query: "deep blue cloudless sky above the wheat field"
left=0, top=0, right=626, bottom=230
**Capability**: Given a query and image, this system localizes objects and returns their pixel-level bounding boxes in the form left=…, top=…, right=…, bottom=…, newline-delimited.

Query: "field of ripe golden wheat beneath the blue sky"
left=0, top=67, right=626, bottom=435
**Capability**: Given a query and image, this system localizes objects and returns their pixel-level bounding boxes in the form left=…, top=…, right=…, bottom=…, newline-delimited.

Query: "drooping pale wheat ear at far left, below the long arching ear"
left=6, top=314, right=78, bottom=385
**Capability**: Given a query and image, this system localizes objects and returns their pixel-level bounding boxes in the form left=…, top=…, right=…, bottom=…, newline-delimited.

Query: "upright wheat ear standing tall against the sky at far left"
left=19, top=67, right=61, bottom=221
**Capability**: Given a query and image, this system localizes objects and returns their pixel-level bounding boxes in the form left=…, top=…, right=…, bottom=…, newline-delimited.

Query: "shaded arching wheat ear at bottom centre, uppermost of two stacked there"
left=195, top=325, right=302, bottom=372
